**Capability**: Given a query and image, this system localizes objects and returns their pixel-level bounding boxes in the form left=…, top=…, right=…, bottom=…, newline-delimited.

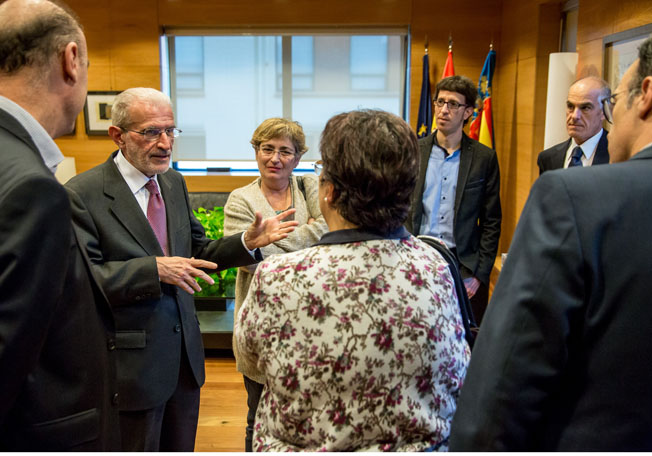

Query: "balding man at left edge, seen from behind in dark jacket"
left=0, top=0, right=120, bottom=451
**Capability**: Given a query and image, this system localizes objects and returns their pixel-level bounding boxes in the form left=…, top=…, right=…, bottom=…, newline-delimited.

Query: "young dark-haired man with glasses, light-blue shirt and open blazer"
left=406, top=76, right=502, bottom=324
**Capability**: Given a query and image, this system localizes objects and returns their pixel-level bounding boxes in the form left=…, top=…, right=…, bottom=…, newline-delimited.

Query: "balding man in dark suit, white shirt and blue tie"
left=537, top=76, right=611, bottom=174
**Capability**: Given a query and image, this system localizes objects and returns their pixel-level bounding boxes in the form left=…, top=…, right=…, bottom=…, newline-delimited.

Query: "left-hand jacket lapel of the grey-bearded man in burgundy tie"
left=103, top=153, right=163, bottom=256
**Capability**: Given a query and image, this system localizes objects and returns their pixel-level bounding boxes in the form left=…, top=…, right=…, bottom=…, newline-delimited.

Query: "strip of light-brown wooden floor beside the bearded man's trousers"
left=195, top=351, right=247, bottom=451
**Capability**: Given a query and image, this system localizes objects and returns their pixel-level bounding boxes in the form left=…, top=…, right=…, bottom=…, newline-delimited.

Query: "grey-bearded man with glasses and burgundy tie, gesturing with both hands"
left=66, top=88, right=297, bottom=451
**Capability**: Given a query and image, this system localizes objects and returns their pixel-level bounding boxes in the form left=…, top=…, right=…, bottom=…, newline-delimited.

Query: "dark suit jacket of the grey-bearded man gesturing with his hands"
left=66, top=152, right=254, bottom=410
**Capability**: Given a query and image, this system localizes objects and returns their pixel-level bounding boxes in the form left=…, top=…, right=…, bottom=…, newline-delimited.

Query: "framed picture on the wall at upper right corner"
left=602, top=24, right=652, bottom=90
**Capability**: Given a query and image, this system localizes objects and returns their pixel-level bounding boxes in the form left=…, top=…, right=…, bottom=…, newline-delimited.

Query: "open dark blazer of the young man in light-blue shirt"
left=406, top=131, right=502, bottom=285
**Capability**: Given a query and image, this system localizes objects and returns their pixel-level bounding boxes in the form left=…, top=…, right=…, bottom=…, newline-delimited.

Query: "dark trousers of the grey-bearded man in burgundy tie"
left=120, top=349, right=200, bottom=452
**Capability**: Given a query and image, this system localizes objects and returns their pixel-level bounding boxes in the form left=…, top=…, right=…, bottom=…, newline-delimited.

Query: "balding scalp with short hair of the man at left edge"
left=0, top=0, right=85, bottom=76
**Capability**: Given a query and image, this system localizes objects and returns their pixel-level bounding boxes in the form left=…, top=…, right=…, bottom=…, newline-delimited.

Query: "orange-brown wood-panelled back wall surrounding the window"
left=57, top=0, right=501, bottom=183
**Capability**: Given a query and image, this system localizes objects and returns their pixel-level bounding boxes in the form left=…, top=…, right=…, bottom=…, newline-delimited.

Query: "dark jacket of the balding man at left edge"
left=0, top=109, right=120, bottom=451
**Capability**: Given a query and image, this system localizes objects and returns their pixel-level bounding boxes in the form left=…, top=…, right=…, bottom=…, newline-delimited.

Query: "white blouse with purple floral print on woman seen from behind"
left=235, top=228, right=470, bottom=451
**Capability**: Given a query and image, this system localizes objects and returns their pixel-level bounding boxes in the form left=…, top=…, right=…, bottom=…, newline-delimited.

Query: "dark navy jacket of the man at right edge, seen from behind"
left=450, top=148, right=652, bottom=451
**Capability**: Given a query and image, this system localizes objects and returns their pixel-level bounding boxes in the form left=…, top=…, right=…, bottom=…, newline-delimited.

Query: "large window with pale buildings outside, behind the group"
left=161, top=31, right=407, bottom=170
